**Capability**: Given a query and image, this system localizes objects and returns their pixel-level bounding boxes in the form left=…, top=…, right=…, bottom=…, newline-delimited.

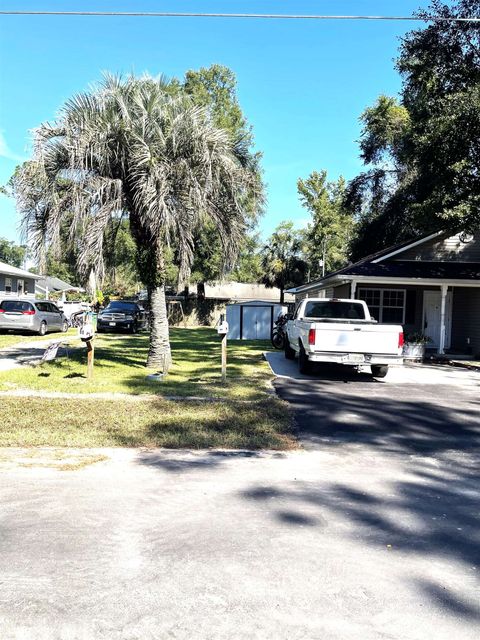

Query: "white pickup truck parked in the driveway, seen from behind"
left=285, top=298, right=403, bottom=378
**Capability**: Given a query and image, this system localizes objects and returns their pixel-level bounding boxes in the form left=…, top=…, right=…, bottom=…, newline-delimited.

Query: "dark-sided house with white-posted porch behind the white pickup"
left=290, top=231, right=480, bottom=354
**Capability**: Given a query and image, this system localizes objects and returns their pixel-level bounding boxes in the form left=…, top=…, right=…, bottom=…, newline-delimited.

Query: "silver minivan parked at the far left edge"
left=0, top=298, right=68, bottom=336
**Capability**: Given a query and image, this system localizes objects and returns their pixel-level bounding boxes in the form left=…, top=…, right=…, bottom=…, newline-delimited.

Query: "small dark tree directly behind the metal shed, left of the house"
left=262, top=221, right=307, bottom=304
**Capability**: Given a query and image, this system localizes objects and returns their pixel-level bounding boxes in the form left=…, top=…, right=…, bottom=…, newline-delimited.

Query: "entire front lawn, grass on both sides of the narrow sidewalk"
left=0, top=328, right=295, bottom=449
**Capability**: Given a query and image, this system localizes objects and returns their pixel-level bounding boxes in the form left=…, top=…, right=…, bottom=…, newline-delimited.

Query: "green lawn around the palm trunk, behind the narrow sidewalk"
left=0, top=328, right=271, bottom=400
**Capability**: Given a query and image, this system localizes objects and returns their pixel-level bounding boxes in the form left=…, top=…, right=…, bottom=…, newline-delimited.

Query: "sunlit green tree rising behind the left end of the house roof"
left=297, top=171, right=355, bottom=279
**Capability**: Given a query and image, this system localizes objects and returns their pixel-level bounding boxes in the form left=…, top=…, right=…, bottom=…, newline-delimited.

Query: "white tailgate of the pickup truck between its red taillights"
left=311, top=322, right=402, bottom=355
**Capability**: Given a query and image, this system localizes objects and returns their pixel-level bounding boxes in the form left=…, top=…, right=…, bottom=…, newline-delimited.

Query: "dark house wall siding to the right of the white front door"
left=451, top=287, right=480, bottom=355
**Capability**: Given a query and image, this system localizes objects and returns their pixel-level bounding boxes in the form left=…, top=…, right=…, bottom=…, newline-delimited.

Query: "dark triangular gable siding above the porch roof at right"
left=392, top=232, right=480, bottom=262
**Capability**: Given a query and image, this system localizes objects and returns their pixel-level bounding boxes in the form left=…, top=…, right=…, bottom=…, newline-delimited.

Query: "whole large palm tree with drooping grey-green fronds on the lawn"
left=14, top=76, right=261, bottom=370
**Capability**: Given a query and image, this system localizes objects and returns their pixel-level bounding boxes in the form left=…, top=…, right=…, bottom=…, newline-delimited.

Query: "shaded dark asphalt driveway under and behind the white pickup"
left=267, top=352, right=480, bottom=455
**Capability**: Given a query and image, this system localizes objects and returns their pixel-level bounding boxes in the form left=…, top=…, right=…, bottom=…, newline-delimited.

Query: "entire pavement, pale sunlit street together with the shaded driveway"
left=0, top=358, right=480, bottom=640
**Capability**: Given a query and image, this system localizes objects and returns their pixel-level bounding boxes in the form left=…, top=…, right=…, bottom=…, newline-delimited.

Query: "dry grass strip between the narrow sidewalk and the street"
left=0, top=397, right=295, bottom=449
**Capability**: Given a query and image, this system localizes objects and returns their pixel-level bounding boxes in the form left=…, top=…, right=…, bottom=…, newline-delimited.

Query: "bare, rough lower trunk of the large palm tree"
left=147, top=284, right=172, bottom=373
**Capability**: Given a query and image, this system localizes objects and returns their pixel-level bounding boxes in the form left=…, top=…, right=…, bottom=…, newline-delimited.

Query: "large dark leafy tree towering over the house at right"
left=346, top=0, right=480, bottom=258
